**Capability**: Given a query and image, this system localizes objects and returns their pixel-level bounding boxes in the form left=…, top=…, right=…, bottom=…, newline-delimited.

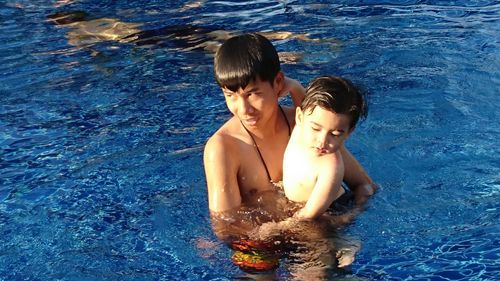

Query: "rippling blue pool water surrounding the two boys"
left=0, top=0, right=500, bottom=280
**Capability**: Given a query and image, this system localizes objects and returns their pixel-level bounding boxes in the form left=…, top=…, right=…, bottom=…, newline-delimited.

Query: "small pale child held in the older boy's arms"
left=283, top=76, right=366, bottom=219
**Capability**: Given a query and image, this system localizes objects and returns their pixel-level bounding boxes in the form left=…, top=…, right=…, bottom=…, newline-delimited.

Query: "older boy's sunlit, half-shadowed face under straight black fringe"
left=222, top=72, right=283, bottom=128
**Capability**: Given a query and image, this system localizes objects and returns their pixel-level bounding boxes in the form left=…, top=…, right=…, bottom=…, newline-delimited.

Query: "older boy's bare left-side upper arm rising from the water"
left=203, top=135, right=241, bottom=212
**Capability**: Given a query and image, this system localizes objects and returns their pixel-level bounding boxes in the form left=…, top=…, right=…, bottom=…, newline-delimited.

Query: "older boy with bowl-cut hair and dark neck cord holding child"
left=204, top=34, right=373, bottom=213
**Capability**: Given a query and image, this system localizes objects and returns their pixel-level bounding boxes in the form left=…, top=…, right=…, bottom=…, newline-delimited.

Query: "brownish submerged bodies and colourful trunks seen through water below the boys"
left=212, top=191, right=360, bottom=280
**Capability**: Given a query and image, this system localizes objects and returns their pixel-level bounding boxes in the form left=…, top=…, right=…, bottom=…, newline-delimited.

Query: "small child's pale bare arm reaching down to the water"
left=301, top=157, right=344, bottom=219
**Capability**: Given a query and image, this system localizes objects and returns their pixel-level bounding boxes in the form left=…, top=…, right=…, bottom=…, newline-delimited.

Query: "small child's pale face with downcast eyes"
left=295, top=106, right=352, bottom=156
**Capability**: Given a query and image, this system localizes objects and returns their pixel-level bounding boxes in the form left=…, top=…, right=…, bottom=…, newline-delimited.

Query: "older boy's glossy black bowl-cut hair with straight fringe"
left=214, top=33, right=280, bottom=92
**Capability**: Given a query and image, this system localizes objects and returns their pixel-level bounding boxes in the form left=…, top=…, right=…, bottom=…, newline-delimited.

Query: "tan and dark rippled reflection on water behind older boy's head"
left=47, top=11, right=338, bottom=63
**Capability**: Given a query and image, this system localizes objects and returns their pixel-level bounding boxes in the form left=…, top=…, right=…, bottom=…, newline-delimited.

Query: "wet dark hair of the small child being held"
left=301, top=76, right=368, bottom=128
